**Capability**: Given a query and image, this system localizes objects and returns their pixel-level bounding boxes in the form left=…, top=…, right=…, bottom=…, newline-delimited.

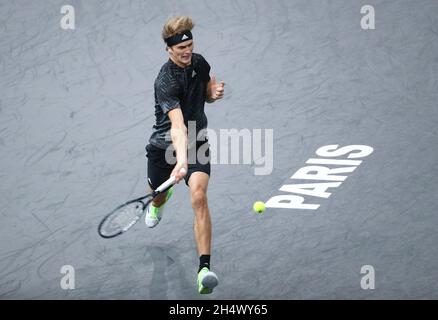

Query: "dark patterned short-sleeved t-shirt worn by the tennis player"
left=149, top=53, right=210, bottom=149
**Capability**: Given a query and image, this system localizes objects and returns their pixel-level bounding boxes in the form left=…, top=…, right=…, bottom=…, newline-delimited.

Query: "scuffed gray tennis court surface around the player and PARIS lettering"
left=0, top=0, right=438, bottom=299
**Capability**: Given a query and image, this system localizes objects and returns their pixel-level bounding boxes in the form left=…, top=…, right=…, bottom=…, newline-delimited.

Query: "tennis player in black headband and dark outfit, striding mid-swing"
left=145, top=16, right=225, bottom=294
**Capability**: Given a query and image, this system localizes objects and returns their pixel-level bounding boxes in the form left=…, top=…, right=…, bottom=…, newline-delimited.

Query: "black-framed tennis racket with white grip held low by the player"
left=97, top=171, right=183, bottom=238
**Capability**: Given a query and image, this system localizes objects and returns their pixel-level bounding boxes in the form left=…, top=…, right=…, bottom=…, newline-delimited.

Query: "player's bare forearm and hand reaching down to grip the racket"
left=168, top=108, right=187, bottom=182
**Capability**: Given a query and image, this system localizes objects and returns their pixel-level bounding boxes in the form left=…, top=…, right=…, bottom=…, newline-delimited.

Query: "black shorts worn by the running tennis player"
left=146, top=140, right=210, bottom=190
